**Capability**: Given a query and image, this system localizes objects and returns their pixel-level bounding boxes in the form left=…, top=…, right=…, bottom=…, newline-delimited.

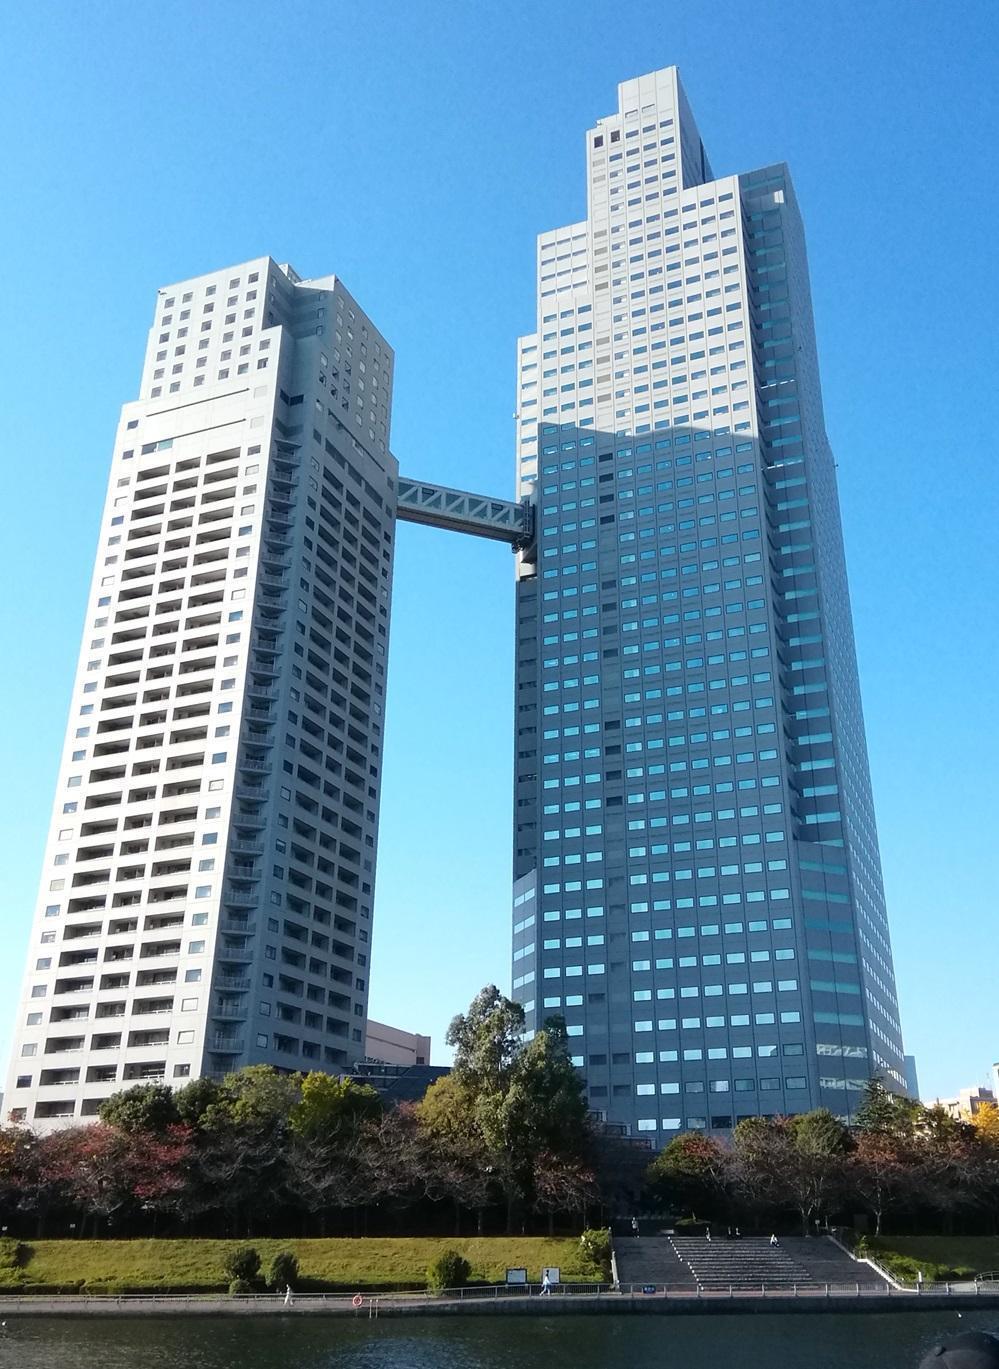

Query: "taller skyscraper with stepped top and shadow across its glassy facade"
left=513, top=68, right=905, bottom=1144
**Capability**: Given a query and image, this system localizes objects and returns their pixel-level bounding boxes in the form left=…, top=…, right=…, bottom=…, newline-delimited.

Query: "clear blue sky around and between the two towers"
left=0, top=0, right=999, bottom=1097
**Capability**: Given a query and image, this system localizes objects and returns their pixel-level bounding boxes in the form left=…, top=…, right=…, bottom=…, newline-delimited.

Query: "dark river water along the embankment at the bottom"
left=7, top=1310, right=999, bottom=1369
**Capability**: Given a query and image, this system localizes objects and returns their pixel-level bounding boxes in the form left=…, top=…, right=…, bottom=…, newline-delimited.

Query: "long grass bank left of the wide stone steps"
left=0, top=1236, right=602, bottom=1292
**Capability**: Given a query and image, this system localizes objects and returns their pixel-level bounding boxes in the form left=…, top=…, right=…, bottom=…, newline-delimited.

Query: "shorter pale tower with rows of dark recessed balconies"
left=7, top=257, right=397, bottom=1129
